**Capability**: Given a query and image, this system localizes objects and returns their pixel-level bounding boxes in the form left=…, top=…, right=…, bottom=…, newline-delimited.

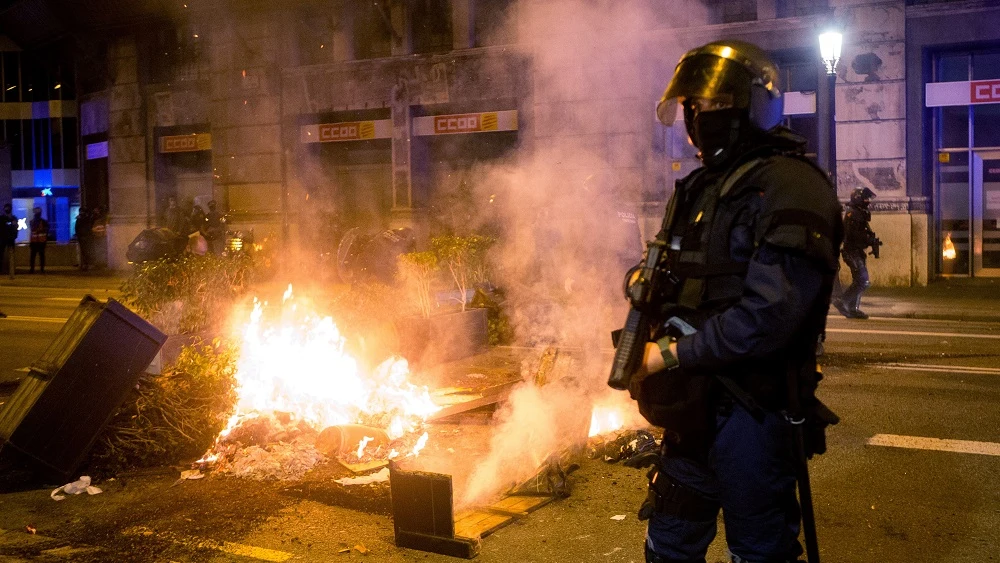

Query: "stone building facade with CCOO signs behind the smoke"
left=5, top=0, right=1000, bottom=285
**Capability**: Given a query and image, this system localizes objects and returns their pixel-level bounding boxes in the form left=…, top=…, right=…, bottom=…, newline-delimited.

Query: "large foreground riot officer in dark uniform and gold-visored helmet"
left=629, top=41, right=843, bottom=563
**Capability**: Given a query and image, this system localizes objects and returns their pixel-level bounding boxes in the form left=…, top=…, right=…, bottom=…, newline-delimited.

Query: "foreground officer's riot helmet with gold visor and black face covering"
left=656, top=40, right=783, bottom=166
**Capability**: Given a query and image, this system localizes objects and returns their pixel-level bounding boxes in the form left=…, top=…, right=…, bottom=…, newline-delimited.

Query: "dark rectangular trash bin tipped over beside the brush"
left=0, top=295, right=166, bottom=483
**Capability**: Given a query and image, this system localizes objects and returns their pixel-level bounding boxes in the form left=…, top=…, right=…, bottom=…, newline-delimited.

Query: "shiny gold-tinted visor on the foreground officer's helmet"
left=656, top=53, right=753, bottom=125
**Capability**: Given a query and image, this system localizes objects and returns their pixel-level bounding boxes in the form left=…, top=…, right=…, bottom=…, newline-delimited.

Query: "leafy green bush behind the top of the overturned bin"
left=121, top=253, right=255, bottom=333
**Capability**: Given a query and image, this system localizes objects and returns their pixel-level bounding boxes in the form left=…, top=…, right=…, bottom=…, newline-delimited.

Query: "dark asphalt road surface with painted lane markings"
left=0, top=294, right=1000, bottom=563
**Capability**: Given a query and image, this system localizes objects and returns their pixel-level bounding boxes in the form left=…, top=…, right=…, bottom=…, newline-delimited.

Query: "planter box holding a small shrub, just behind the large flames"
left=396, top=309, right=487, bottom=366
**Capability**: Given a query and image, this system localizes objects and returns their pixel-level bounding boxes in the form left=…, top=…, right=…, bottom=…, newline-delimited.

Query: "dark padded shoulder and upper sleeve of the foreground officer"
left=753, top=156, right=843, bottom=270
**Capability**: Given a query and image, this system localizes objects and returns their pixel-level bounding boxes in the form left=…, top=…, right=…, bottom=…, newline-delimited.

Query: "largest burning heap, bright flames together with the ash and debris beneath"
left=196, top=286, right=440, bottom=480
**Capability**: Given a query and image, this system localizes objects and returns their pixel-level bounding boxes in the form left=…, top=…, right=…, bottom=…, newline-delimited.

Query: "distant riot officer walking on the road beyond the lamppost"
left=833, top=188, right=882, bottom=319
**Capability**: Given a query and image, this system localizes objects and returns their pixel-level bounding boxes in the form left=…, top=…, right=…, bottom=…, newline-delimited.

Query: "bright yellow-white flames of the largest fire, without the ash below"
left=202, top=285, right=440, bottom=470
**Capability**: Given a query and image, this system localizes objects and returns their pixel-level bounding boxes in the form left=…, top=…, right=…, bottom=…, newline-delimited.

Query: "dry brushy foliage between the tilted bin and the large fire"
left=90, top=340, right=238, bottom=474
